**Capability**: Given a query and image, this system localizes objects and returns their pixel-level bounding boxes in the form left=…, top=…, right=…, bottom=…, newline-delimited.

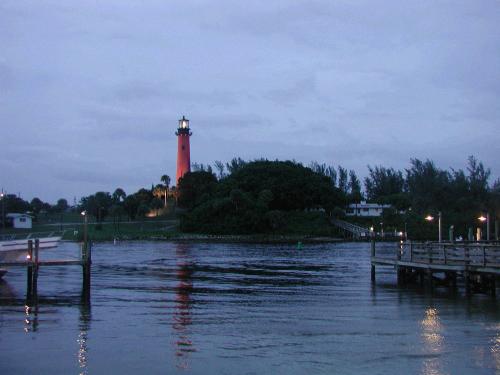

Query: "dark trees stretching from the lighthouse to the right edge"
left=179, top=156, right=500, bottom=238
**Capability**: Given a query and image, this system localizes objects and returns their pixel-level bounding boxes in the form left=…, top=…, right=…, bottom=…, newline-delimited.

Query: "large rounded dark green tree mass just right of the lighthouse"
left=178, top=159, right=345, bottom=234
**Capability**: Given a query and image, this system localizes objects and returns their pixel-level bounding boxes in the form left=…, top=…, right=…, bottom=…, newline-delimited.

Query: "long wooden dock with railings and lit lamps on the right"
left=371, top=240, right=500, bottom=295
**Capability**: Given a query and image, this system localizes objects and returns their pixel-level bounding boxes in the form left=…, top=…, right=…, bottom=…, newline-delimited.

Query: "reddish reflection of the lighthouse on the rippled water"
left=172, top=244, right=195, bottom=368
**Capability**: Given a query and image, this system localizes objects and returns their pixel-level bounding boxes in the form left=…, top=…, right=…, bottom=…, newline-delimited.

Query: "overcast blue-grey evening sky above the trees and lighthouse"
left=0, top=0, right=500, bottom=202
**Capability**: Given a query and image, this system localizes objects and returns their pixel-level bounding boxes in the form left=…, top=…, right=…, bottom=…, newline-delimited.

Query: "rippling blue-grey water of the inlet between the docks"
left=0, top=242, right=500, bottom=375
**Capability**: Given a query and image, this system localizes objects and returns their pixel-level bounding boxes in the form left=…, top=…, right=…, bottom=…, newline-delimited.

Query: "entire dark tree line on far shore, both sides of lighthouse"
left=3, top=156, right=500, bottom=237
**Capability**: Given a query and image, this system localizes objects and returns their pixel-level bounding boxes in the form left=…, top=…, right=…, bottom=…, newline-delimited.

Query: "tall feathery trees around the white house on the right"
left=358, top=156, right=500, bottom=239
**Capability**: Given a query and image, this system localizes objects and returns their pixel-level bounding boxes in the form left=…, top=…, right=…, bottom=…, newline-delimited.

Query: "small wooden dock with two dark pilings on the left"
left=0, top=239, right=92, bottom=298
